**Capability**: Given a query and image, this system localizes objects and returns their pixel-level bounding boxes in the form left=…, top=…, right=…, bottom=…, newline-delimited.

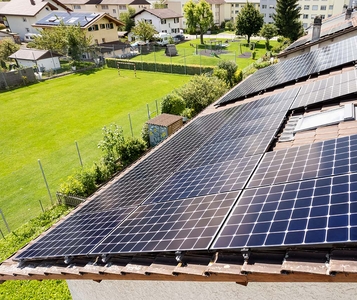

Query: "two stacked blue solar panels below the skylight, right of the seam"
left=213, top=135, right=357, bottom=249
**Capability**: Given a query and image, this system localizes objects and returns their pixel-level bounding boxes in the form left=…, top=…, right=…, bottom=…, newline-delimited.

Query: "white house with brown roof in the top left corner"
left=0, top=0, right=70, bottom=40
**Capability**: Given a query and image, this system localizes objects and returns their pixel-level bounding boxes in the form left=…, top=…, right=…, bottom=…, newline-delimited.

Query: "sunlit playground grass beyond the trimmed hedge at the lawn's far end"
left=131, top=39, right=278, bottom=69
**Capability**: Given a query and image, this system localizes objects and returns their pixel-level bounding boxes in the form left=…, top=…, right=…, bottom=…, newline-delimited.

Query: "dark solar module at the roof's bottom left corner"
left=16, top=207, right=134, bottom=260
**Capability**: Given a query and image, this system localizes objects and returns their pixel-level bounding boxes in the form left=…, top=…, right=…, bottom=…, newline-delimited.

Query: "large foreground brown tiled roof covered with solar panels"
left=0, top=14, right=357, bottom=285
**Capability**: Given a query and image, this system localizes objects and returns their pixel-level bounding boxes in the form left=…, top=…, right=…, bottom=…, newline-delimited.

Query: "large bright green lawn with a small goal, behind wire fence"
left=0, top=69, right=190, bottom=233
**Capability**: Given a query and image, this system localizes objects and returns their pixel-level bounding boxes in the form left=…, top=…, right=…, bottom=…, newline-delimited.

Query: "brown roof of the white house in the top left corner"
left=1, top=0, right=70, bottom=17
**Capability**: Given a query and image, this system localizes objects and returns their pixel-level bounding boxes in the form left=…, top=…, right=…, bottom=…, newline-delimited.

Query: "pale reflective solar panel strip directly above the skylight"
left=292, top=70, right=357, bottom=108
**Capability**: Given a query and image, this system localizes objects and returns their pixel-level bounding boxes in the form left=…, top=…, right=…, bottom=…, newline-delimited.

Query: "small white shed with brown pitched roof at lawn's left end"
left=9, top=49, right=61, bottom=72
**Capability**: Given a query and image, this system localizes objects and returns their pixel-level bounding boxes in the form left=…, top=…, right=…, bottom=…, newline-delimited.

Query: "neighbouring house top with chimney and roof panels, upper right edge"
left=278, top=8, right=357, bottom=60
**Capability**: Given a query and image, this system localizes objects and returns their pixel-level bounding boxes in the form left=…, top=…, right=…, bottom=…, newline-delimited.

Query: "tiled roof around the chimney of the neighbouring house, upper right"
left=278, top=12, right=357, bottom=57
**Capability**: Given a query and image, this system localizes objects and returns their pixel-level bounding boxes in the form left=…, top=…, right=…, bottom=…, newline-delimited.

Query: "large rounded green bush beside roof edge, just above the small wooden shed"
left=177, top=74, right=227, bottom=116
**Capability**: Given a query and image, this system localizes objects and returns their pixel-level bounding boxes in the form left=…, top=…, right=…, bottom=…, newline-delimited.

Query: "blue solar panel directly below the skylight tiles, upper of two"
left=248, top=135, right=357, bottom=188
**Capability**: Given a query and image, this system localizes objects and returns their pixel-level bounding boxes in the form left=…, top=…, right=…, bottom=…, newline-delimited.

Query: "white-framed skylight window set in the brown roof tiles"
left=294, top=103, right=356, bottom=133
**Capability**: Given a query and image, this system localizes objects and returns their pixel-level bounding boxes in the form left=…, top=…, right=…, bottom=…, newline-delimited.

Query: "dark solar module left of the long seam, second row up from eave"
left=145, top=155, right=261, bottom=204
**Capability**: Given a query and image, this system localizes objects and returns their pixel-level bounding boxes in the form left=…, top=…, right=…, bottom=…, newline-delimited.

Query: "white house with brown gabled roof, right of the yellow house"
left=132, top=8, right=182, bottom=36
